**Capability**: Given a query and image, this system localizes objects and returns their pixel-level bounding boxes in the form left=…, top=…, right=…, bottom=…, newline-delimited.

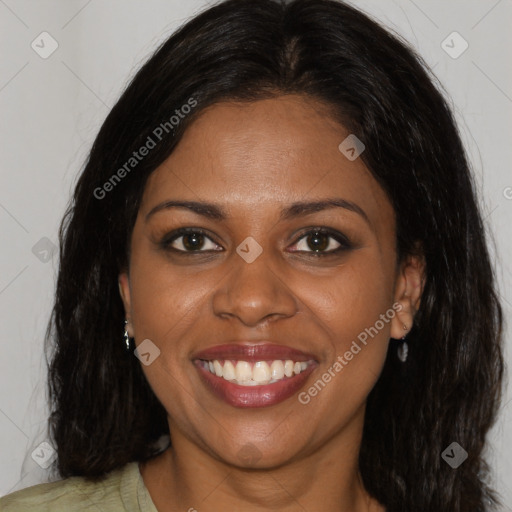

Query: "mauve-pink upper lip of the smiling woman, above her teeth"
left=192, top=342, right=316, bottom=362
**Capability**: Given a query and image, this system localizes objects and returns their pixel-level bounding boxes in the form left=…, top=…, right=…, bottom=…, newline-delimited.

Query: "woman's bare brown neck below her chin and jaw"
left=141, top=411, right=382, bottom=512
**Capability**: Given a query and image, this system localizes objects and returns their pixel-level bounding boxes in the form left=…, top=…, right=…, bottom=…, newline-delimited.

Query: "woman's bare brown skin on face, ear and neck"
left=119, top=95, right=424, bottom=512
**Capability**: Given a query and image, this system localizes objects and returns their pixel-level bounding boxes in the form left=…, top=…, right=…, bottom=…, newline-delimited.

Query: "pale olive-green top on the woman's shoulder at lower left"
left=0, top=462, right=158, bottom=512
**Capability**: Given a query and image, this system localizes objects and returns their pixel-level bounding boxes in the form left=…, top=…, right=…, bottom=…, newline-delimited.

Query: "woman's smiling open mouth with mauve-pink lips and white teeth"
left=193, top=344, right=318, bottom=407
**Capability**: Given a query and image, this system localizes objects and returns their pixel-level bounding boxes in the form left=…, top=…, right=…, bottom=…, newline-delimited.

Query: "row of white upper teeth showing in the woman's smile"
left=203, top=359, right=311, bottom=386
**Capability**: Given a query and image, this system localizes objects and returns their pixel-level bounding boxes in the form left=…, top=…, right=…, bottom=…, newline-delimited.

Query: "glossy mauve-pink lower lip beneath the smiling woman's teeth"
left=194, top=361, right=316, bottom=407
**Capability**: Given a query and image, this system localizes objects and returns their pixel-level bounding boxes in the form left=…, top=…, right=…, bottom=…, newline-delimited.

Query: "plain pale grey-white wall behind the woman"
left=0, top=0, right=512, bottom=510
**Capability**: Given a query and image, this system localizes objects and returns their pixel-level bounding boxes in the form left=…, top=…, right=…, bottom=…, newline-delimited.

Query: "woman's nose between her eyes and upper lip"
left=213, top=251, right=298, bottom=327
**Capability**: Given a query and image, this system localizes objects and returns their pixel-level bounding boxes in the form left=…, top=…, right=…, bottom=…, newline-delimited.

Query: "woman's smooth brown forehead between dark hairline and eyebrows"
left=141, top=95, right=393, bottom=230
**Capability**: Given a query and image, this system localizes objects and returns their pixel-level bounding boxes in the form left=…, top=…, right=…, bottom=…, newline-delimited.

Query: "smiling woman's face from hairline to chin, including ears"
left=120, top=96, right=421, bottom=467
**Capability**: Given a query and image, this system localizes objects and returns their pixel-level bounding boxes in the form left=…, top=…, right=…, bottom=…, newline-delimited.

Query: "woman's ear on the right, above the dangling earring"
left=390, top=248, right=425, bottom=339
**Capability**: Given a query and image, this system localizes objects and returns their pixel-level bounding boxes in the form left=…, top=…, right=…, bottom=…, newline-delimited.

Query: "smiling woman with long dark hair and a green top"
left=0, top=0, right=503, bottom=512
